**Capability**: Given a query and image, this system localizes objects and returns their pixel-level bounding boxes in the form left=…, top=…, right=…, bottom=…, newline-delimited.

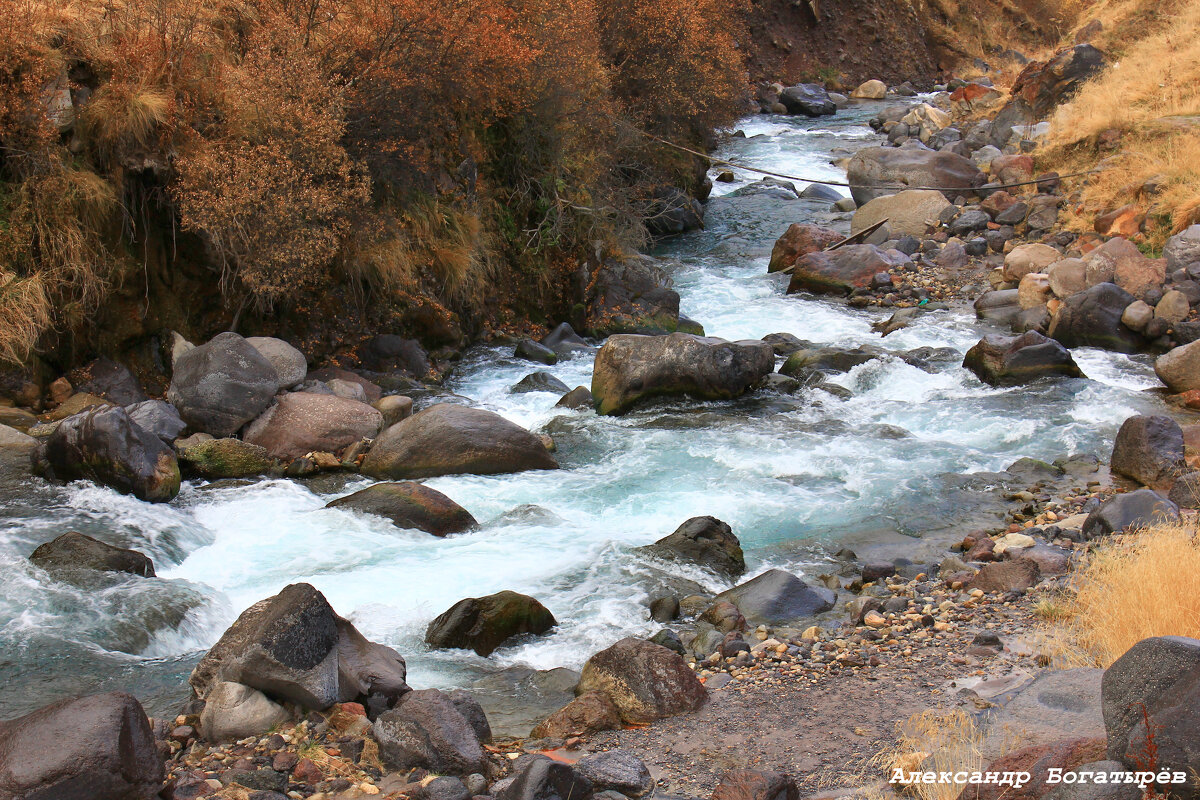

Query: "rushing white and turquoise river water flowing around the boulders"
left=0, top=104, right=1158, bottom=717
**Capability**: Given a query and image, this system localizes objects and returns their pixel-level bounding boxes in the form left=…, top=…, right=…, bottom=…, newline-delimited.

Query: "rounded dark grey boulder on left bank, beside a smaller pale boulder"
left=167, top=331, right=280, bottom=437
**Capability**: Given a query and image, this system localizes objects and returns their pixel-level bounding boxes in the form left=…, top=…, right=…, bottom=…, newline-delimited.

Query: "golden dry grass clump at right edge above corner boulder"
left=1042, top=525, right=1200, bottom=667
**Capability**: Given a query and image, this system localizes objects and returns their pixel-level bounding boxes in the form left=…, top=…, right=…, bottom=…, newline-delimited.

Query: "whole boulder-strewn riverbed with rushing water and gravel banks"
left=0, top=61, right=1200, bottom=800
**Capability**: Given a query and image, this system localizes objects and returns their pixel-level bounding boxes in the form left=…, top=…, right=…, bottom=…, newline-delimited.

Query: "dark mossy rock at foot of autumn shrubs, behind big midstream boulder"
left=587, top=255, right=679, bottom=337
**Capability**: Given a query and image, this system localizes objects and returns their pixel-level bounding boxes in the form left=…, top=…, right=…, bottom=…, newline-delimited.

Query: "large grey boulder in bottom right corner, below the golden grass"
left=1100, top=636, right=1200, bottom=772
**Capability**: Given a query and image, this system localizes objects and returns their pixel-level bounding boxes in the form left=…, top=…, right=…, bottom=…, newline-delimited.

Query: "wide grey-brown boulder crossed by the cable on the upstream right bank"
left=846, top=148, right=986, bottom=206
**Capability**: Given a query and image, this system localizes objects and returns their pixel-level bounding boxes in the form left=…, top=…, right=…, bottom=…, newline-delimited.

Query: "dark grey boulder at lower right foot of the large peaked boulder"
left=372, top=688, right=487, bottom=775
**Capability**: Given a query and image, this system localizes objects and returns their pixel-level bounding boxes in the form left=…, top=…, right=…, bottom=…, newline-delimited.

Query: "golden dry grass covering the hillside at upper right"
left=1043, top=0, right=1200, bottom=251
